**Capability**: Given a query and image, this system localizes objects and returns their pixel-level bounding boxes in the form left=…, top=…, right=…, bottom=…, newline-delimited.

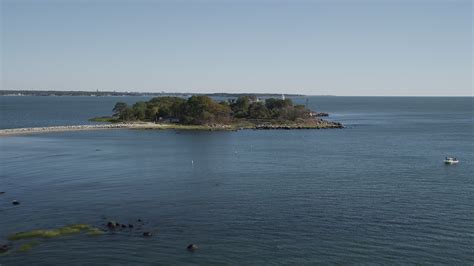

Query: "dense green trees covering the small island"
left=113, top=96, right=311, bottom=125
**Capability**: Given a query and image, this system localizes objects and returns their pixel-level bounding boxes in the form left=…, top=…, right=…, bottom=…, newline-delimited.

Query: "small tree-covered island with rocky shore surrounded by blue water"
left=91, top=95, right=343, bottom=130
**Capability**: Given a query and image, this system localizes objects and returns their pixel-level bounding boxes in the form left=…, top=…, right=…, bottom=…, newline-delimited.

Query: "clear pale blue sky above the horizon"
left=0, top=0, right=473, bottom=96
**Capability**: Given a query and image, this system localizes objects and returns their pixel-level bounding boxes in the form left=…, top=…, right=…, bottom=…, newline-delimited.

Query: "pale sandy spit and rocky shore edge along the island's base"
left=0, top=120, right=343, bottom=137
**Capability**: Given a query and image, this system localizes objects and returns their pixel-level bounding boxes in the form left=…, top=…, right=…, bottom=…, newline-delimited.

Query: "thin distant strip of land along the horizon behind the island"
left=0, top=90, right=304, bottom=97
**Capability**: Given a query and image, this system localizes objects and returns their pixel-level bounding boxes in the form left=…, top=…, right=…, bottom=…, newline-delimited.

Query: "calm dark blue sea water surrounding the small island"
left=0, top=97, right=474, bottom=265
